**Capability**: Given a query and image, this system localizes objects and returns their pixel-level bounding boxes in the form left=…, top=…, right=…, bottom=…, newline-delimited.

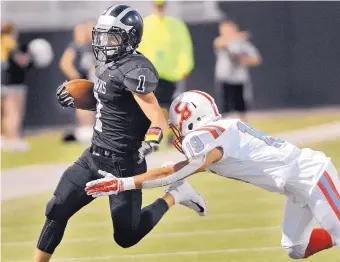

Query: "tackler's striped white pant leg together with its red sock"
left=305, top=163, right=340, bottom=257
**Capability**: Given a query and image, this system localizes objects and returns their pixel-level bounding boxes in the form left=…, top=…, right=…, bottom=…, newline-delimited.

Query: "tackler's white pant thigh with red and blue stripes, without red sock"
left=308, top=162, right=340, bottom=246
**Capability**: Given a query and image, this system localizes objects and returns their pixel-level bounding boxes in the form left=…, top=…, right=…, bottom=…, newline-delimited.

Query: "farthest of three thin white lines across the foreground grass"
left=1, top=209, right=282, bottom=231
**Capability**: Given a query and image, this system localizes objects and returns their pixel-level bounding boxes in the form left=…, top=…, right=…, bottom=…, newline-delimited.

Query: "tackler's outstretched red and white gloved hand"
left=85, top=170, right=122, bottom=198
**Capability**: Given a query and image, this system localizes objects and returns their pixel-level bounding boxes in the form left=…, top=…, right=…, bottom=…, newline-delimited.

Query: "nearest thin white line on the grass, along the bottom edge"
left=8, top=247, right=281, bottom=262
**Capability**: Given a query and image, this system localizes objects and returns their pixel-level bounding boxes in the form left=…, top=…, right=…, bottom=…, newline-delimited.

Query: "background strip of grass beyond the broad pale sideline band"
left=1, top=114, right=340, bottom=169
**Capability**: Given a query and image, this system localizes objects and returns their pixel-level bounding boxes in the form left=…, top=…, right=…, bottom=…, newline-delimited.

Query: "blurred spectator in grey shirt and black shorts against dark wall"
left=214, top=20, right=261, bottom=121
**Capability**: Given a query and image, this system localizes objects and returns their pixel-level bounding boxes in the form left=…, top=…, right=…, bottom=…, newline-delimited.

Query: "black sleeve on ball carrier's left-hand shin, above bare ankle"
left=37, top=219, right=67, bottom=254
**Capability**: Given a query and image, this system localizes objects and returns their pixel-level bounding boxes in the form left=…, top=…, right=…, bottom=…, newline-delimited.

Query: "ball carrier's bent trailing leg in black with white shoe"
left=110, top=160, right=206, bottom=248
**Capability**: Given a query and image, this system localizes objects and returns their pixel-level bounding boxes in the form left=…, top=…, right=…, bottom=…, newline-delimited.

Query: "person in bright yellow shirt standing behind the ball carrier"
left=138, top=1, right=194, bottom=145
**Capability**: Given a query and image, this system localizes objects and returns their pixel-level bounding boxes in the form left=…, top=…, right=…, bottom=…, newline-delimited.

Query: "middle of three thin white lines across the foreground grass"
left=1, top=226, right=280, bottom=247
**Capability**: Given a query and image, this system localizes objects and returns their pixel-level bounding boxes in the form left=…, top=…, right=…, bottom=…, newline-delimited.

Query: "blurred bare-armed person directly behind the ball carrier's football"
left=59, top=23, right=94, bottom=144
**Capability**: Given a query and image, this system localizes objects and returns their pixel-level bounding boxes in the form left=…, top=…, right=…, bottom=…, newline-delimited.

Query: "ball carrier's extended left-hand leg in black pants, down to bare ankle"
left=33, top=151, right=93, bottom=262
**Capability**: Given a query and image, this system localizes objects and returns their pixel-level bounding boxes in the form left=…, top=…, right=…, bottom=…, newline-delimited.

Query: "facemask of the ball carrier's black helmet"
left=92, top=27, right=128, bottom=62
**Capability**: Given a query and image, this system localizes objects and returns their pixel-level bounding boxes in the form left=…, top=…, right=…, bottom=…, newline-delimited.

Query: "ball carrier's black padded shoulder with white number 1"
left=120, top=54, right=159, bottom=94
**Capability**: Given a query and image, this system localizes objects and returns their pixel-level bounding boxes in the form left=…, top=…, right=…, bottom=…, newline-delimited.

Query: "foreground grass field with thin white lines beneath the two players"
left=1, top=141, right=340, bottom=262
